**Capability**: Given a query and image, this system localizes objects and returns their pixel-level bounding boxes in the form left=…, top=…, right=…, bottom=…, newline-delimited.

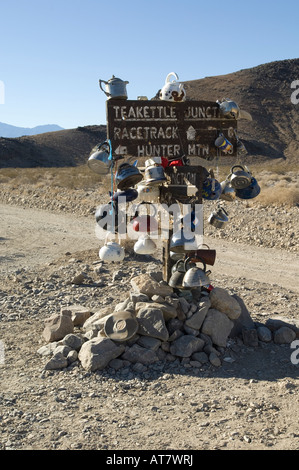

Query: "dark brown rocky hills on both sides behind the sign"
left=0, top=59, right=299, bottom=167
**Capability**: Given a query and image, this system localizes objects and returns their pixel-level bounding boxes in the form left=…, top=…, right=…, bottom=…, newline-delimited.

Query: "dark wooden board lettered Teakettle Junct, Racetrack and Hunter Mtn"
left=106, top=99, right=237, bottom=159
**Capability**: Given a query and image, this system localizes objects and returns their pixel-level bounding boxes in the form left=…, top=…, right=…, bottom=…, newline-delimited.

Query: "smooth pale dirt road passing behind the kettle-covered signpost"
left=0, top=204, right=299, bottom=293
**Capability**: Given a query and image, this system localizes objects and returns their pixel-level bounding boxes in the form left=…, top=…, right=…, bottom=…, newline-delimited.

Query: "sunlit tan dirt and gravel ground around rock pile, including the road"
left=0, top=204, right=299, bottom=455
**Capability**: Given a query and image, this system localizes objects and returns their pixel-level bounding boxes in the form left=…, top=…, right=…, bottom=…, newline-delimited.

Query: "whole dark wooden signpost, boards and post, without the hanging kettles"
left=106, top=99, right=237, bottom=282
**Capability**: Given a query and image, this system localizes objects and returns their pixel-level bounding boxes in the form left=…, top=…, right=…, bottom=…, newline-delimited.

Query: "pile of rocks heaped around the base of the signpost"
left=38, top=273, right=299, bottom=372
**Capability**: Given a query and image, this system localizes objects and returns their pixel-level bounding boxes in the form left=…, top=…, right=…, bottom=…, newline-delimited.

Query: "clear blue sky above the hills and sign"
left=0, top=0, right=299, bottom=128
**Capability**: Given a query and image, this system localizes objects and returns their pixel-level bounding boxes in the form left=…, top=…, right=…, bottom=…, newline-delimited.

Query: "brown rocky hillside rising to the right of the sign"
left=184, top=59, right=299, bottom=160
